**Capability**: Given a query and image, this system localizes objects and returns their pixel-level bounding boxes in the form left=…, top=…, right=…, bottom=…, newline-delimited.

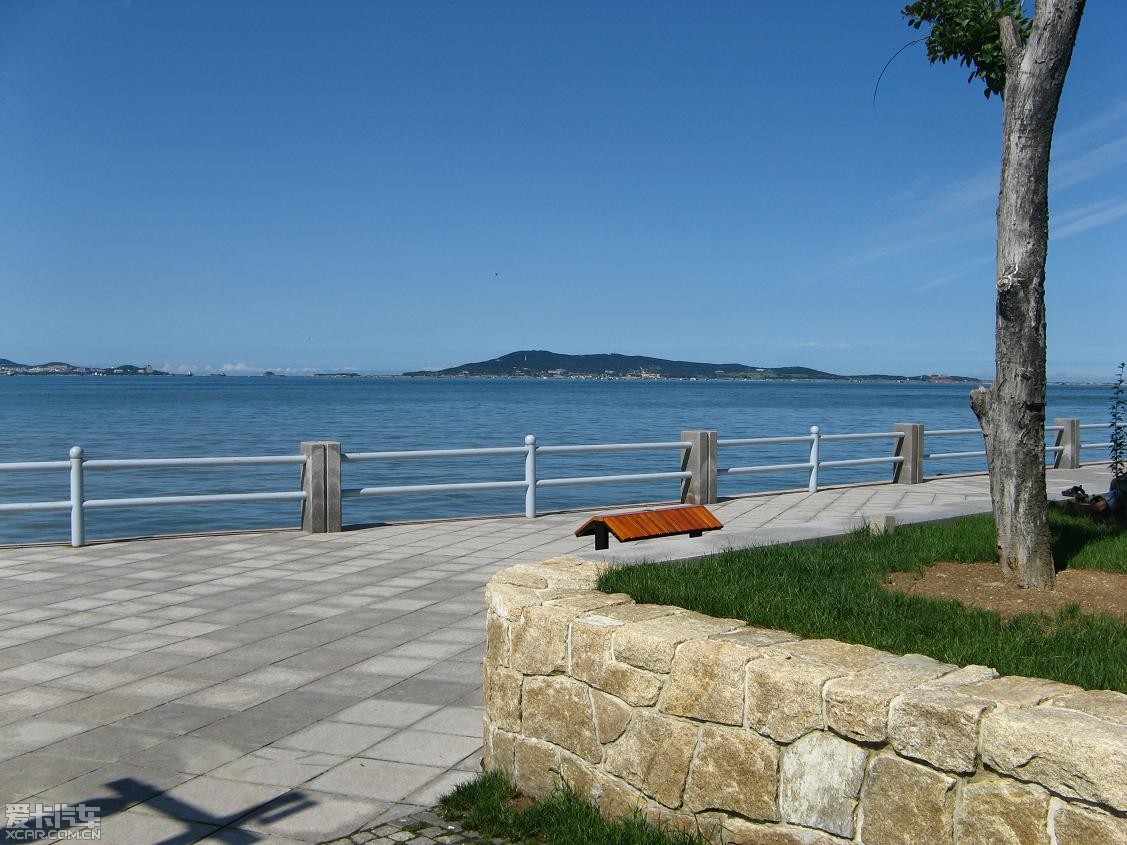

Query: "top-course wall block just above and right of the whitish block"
left=822, top=655, right=956, bottom=742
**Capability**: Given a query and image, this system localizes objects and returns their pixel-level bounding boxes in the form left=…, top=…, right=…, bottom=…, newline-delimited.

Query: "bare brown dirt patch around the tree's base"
left=886, top=562, right=1127, bottom=622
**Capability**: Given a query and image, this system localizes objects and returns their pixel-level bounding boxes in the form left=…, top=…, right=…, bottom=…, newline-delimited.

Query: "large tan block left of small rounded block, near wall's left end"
left=521, top=677, right=603, bottom=763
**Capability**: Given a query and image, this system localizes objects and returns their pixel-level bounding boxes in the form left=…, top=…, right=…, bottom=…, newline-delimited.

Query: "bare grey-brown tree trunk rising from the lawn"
left=970, top=0, right=1084, bottom=587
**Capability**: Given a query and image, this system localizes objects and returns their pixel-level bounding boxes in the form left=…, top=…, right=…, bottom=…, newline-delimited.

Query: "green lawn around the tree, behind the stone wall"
left=598, top=510, right=1127, bottom=693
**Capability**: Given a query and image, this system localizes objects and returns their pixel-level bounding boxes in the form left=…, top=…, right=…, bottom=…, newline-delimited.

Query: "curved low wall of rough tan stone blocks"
left=485, top=558, right=1127, bottom=845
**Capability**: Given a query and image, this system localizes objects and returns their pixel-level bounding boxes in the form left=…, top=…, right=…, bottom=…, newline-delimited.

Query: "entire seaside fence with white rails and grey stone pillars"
left=0, top=419, right=1111, bottom=545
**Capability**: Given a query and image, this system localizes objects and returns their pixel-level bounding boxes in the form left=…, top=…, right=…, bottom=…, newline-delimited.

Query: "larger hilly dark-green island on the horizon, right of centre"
left=403, top=349, right=982, bottom=384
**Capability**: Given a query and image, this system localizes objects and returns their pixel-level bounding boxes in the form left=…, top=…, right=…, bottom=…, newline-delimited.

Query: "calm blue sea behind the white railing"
left=0, top=376, right=1110, bottom=543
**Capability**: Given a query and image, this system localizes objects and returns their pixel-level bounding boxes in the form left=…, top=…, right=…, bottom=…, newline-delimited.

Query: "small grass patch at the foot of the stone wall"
left=438, top=772, right=704, bottom=845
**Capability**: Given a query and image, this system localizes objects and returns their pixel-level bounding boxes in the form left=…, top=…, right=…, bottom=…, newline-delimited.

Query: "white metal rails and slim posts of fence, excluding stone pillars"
left=0, top=419, right=1111, bottom=546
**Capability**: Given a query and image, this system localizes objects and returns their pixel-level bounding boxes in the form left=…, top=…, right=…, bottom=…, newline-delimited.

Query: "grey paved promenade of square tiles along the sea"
left=0, top=469, right=1107, bottom=845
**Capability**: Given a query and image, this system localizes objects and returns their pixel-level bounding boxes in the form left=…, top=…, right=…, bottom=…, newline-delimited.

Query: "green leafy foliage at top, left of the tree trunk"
left=903, top=0, right=1032, bottom=97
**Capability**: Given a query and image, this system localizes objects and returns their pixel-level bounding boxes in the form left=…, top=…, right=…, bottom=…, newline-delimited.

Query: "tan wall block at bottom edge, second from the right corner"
left=955, top=777, right=1049, bottom=845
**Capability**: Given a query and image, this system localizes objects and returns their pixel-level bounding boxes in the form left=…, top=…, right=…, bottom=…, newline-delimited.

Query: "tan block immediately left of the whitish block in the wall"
left=680, top=724, right=779, bottom=821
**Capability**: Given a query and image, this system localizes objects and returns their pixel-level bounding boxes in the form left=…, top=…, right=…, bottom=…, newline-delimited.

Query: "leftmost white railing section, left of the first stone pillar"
left=0, top=446, right=305, bottom=546
